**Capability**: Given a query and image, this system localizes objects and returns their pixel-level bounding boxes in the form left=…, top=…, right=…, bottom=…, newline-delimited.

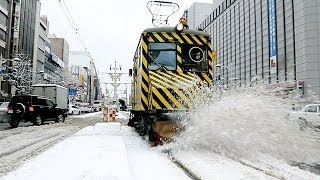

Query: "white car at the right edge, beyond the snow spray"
left=290, top=104, right=320, bottom=127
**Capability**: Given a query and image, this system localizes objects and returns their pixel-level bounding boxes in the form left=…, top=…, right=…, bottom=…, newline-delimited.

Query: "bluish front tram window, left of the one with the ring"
left=148, top=43, right=177, bottom=70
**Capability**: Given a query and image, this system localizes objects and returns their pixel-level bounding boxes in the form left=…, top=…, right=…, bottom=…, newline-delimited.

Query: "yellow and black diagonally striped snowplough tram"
left=128, top=23, right=215, bottom=141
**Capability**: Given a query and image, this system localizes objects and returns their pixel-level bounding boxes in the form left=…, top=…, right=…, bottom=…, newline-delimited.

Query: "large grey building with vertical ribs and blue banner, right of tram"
left=198, top=0, right=320, bottom=100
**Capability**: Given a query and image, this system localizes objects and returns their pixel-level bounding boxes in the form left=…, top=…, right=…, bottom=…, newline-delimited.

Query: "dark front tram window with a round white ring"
left=181, top=44, right=208, bottom=72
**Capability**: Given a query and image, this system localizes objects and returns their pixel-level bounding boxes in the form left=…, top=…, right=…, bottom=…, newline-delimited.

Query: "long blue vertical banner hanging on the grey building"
left=269, top=0, right=277, bottom=74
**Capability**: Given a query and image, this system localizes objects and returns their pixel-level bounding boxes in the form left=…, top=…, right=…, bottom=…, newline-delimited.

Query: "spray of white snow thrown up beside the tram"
left=165, top=81, right=320, bottom=163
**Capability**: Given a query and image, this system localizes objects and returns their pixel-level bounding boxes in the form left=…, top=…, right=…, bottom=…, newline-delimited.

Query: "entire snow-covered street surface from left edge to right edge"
left=0, top=112, right=320, bottom=180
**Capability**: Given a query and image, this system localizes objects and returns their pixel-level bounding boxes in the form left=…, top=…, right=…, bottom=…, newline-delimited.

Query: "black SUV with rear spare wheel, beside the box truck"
left=8, top=95, right=67, bottom=128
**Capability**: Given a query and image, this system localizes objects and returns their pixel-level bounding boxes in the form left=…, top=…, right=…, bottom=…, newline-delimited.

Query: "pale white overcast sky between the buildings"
left=41, top=0, right=213, bottom=97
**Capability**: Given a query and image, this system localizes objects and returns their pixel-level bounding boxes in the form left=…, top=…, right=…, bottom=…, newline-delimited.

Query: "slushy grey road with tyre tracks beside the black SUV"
left=0, top=112, right=101, bottom=177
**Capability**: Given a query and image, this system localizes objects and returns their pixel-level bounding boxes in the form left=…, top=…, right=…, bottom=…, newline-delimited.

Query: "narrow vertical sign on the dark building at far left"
left=13, top=0, right=21, bottom=54
